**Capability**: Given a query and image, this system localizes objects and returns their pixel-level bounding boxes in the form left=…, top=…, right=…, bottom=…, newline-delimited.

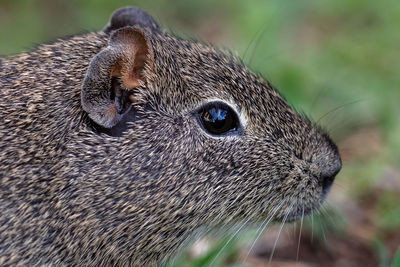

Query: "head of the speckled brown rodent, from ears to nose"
left=82, top=5, right=341, bottom=251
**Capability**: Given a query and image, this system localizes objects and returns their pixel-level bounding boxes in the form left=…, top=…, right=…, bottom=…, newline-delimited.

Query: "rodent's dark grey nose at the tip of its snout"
left=319, top=147, right=342, bottom=193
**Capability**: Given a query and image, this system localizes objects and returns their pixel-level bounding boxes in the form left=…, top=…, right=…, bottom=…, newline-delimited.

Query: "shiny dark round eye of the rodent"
left=198, top=103, right=238, bottom=135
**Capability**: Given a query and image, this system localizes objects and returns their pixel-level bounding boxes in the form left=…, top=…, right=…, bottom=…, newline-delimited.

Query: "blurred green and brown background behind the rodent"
left=0, top=0, right=400, bottom=266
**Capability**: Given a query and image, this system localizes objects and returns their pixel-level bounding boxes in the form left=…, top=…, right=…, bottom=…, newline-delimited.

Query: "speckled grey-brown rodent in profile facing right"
left=0, top=7, right=341, bottom=266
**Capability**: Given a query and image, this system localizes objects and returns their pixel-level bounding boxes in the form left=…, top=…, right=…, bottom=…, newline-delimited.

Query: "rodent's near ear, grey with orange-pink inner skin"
left=81, top=27, right=153, bottom=128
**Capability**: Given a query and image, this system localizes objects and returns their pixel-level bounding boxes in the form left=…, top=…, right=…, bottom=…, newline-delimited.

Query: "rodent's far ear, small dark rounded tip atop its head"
left=103, top=7, right=159, bottom=33
